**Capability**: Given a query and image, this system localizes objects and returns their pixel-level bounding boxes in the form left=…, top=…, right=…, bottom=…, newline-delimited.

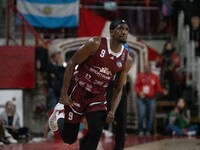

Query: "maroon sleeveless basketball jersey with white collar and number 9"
left=74, top=38, right=128, bottom=93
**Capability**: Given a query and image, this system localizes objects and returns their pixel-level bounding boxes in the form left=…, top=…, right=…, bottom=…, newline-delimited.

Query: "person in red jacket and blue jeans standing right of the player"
left=135, top=63, right=167, bottom=135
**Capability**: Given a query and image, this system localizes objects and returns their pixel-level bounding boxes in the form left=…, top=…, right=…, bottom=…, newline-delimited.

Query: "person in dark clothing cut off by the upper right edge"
left=190, top=16, right=200, bottom=57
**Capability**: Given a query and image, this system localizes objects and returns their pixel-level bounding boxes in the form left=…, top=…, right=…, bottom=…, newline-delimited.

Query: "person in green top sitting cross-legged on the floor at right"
left=167, top=98, right=198, bottom=136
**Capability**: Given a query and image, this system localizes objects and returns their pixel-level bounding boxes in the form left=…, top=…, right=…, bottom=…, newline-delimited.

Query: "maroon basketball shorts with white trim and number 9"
left=65, top=80, right=107, bottom=123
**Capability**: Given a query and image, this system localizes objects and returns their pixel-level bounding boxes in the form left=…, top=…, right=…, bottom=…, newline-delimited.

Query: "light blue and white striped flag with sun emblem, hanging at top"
left=17, top=0, right=79, bottom=28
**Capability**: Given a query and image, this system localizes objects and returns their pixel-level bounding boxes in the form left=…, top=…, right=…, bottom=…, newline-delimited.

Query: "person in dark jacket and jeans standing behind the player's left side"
left=47, top=51, right=65, bottom=110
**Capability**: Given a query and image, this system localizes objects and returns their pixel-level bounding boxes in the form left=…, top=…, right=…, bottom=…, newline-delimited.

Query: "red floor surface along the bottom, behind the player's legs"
left=0, top=134, right=200, bottom=150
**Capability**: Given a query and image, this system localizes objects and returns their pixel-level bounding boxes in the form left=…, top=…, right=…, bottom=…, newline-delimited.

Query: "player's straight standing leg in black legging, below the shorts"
left=80, top=111, right=106, bottom=150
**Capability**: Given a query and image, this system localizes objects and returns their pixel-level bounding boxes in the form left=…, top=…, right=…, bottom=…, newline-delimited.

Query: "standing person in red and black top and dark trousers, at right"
left=156, top=41, right=181, bottom=100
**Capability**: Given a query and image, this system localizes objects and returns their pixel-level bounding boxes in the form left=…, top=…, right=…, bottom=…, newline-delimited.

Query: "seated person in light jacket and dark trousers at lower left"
left=0, top=101, right=28, bottom=140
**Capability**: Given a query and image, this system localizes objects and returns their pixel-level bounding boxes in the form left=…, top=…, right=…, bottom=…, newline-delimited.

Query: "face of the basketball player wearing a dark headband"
left=112, top=24, right=129, bottom=43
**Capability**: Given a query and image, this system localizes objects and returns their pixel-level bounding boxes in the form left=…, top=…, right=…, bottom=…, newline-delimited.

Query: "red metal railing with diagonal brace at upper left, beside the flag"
left=6, top=0, right=50, bottom=48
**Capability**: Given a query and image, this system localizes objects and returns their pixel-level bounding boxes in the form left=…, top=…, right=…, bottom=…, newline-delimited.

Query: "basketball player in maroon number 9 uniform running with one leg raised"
left=49, top=19, right=132, bottom=150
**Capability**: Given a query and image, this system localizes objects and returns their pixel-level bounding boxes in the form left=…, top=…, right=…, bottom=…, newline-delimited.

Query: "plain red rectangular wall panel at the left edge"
left=0, top=46, right=35, bottom=89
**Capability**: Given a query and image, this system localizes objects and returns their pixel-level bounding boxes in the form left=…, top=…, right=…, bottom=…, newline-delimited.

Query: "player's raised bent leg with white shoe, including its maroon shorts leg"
left=49, top=80, right=87, bottom=144
